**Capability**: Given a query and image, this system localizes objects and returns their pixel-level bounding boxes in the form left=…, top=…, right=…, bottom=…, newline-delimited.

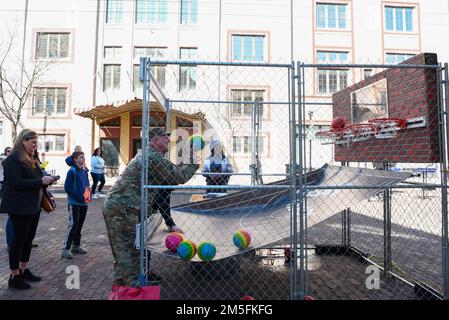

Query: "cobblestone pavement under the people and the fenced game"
left=0, top=189, right=441, bottom=300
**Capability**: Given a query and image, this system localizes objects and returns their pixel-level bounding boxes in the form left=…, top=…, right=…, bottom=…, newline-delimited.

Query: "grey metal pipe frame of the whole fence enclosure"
left=140, top=58, right=449, bottom=299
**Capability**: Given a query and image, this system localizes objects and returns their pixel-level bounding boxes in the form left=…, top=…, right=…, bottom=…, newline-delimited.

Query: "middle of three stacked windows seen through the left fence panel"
left=231, top=89, right=265, bottom=118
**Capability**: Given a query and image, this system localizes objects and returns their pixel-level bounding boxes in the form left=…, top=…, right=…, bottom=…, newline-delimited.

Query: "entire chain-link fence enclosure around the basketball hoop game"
left=134, top=57, right=447, bottom=299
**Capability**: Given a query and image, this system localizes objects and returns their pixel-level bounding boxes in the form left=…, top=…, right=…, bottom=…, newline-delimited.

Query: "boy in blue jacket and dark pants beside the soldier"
left=62, top=151, right=90, bottom=259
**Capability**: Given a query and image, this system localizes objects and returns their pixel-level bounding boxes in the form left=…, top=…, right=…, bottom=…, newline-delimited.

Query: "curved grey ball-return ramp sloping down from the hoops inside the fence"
left=147, top=165, right=410, bottom=261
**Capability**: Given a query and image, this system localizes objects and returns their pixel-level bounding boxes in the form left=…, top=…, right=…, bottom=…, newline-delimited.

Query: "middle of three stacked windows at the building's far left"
left=32, top=88, right=67, bottom=116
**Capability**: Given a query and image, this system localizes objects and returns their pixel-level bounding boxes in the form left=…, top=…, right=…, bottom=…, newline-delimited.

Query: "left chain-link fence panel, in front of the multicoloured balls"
left=139, top=61, right=292, bottom=299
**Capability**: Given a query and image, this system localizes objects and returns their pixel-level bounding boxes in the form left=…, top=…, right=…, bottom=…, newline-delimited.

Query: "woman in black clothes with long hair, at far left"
left=0, top=129, right=54, bottom=290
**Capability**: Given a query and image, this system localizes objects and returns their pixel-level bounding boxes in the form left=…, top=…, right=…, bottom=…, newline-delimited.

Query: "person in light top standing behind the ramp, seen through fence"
left=202, top=140, right=233, bottom=193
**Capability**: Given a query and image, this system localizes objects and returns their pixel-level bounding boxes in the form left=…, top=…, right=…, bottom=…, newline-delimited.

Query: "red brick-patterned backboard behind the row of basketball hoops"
left=332, top=53, right=440, bottom=163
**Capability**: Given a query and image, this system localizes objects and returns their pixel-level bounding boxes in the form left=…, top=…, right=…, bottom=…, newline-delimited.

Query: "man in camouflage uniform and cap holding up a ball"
left=103, top=128, right=199, bottom=285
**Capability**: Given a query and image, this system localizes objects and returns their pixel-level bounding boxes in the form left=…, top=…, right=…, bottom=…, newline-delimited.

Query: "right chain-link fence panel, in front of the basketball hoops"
left=299, top=54, right=448, bottom=299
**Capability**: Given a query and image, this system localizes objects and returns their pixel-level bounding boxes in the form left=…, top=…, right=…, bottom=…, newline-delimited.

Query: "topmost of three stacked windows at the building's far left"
left=36, top=32, right=70, bottom=59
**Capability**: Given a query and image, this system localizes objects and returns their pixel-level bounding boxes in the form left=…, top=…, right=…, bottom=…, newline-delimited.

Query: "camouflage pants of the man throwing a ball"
left=103, top=201, right=140, bottom=286
